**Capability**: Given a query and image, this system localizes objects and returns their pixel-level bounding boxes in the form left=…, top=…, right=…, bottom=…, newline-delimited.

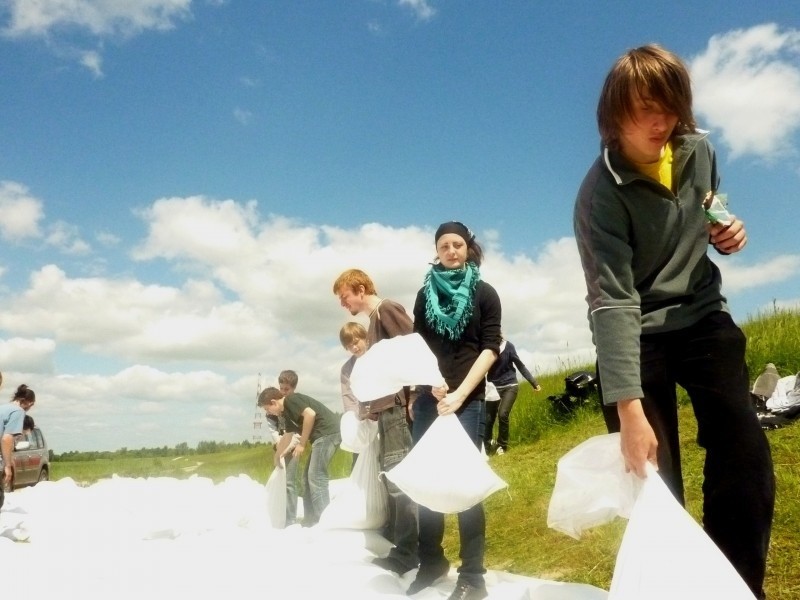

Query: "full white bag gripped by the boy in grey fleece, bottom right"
left=608, top=465, right=755, bottom=600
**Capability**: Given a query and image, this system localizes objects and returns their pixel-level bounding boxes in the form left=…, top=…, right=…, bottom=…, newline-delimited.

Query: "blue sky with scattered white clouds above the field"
left=0, top=0, right=800, bottom=452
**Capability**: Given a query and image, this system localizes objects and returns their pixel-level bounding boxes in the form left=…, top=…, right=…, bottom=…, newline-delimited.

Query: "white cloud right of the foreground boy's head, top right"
left=690, top=23, right=800, bottom=159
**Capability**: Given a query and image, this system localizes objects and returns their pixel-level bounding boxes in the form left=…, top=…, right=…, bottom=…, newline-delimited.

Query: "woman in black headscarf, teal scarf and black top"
left=406, top=221, right=501, bottom=600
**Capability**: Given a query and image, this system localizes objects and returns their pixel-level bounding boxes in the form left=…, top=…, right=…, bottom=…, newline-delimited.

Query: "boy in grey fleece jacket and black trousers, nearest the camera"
left=574, top=45, right=775, bottom=597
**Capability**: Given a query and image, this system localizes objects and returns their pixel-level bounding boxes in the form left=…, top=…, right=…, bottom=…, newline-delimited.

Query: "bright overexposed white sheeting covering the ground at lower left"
left=0, top=475, right=608, bottom=600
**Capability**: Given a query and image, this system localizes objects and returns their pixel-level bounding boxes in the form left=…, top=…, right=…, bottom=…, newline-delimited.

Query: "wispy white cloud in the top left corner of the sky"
left=5, top=0, right=191, bottom=37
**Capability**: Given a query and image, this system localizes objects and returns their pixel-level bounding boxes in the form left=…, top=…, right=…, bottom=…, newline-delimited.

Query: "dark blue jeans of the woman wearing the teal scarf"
left=412, top=393, right=486, bottom=587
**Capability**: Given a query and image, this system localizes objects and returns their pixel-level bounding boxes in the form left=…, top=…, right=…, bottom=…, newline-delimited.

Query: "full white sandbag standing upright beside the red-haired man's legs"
left=319, top=438, right=389, bottom=529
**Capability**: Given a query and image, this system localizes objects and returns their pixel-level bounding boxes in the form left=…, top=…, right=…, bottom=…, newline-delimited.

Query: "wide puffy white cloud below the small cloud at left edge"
left=0, top=265, right=282, bottom=364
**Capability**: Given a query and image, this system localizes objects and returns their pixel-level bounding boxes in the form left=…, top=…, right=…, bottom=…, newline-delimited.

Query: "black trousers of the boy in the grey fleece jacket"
left=598, top=312, right=775, bottom=598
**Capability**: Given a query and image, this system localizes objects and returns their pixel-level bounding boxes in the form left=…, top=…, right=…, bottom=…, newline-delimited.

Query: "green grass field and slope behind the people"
left=52, top=310, right=800, bottom=600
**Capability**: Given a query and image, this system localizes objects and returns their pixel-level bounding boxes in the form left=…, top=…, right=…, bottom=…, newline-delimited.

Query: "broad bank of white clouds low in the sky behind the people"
left=0, top=196, right=800, bottom=451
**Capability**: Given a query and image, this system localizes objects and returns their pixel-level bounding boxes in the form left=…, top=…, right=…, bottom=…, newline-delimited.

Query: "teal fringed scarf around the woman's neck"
left=424, top=262, right=481, bottom=341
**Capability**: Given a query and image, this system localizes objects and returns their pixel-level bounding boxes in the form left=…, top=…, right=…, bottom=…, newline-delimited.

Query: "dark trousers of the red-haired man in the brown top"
left=378, top=406, right=419, bottom=570
